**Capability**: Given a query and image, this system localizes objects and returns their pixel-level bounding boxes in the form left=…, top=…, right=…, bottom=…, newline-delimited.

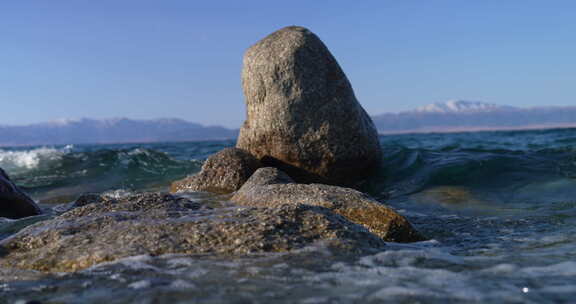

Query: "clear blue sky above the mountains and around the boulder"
left=0, top=0, right=576, bottom=127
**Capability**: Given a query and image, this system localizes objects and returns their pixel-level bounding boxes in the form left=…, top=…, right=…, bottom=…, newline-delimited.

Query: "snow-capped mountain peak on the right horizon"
left=413, top=100, right=514, bottom=113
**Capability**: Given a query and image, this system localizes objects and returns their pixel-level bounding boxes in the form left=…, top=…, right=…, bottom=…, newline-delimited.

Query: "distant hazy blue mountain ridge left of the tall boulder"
left=0, top=118, right=238, bottom=146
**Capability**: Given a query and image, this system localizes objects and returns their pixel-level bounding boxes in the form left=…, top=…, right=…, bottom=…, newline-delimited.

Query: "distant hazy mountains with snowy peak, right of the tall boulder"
left=372, top=100, right=576, bottom=134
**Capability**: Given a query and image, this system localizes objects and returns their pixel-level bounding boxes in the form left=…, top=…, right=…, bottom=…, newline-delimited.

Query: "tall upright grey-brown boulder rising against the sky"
left=236, top=26, right=382, bottom=185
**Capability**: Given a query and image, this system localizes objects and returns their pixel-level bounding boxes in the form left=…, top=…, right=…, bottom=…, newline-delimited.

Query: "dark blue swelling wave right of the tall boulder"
left=368, top=144, right=576, bottom=205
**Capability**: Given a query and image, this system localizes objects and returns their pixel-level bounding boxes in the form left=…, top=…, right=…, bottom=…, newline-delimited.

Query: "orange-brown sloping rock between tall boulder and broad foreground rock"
left=231, top=168, right=424, bottom=242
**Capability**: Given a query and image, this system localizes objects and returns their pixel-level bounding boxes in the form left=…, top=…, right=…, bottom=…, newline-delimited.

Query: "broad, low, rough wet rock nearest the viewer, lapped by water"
left=0, top=193, right=384, bottom=272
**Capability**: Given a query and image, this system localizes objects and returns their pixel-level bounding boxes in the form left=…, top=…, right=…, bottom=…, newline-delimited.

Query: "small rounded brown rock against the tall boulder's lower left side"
left=170, top=148, right=262, bottom=193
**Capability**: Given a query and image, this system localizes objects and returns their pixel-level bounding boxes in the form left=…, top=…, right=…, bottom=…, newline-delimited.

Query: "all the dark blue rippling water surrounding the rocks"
left=0, top=129, right=576, bottom=303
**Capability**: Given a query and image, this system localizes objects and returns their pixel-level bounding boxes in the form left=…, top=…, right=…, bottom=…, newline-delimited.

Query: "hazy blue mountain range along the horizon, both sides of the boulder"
left=0, top=100, right=576, bottom=146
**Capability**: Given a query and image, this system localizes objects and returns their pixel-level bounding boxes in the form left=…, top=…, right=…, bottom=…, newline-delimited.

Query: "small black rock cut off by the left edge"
left=0, top=168, right=41, bottom=219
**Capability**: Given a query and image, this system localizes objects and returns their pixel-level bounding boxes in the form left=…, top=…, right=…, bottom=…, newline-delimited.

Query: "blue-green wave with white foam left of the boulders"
left=0, top=146, right=202, bottom=203
